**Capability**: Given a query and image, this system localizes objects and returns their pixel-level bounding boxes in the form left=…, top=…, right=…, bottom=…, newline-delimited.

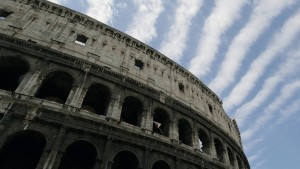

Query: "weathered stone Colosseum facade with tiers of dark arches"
left=0, top=0, right=250, bottom=169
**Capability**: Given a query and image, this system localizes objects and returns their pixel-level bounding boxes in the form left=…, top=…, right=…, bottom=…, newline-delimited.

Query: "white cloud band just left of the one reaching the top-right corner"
left=189, top=0, right=247, bottom=76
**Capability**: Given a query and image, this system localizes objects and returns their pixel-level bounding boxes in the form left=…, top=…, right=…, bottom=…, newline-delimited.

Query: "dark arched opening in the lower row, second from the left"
left=58, top=140, right=97, bottom=169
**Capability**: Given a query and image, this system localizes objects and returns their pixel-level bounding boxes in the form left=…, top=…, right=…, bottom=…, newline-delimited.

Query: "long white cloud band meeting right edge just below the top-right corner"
left=224, top=11, right=300, bottom=111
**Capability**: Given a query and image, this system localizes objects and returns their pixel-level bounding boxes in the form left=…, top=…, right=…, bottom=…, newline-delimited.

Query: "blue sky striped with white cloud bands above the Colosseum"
left=52, top=0, right=300, bottom=169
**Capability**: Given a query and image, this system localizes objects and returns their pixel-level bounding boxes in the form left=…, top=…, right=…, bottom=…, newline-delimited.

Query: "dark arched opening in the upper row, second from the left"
left=36, top=71, right=74, bottom=104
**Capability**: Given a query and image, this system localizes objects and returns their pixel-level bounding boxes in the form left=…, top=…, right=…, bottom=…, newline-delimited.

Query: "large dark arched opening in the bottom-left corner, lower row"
left=0, top=131, right=46, bottom=169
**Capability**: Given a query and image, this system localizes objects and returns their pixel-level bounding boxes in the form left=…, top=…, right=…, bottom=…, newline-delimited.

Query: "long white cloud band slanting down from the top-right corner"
left=209, top=0, right=296, bottom=94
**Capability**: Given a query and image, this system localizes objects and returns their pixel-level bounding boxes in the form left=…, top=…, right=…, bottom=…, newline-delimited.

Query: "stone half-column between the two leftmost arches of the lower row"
left=38, top=127, right=66, bottom=169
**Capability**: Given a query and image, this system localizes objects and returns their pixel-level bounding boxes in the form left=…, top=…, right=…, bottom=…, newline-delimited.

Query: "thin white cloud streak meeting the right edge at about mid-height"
left=242, top=80, right=300, bottom=141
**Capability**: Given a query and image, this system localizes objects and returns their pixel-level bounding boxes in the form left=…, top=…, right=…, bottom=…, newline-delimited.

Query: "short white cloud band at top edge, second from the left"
left=126, top=0, right=164, bottom=43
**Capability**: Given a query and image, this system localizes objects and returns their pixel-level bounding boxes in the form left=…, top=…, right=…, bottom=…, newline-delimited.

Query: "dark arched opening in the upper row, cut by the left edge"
left=0, top=56, right=29, bottom=92
